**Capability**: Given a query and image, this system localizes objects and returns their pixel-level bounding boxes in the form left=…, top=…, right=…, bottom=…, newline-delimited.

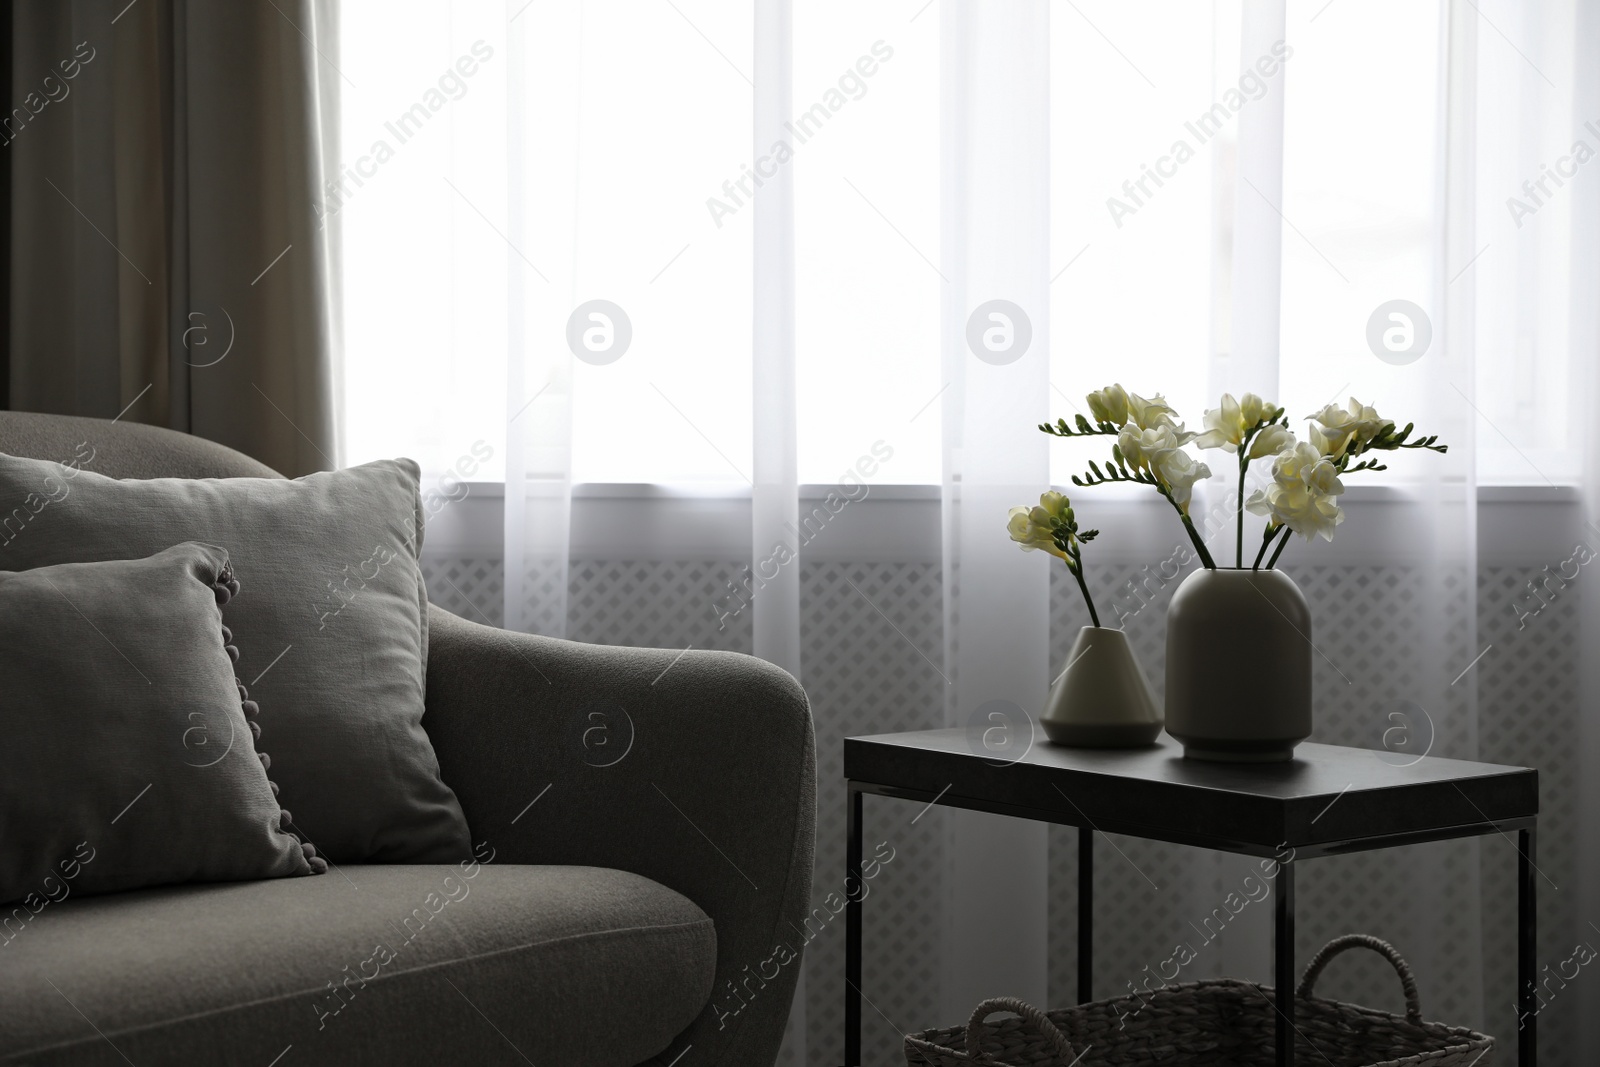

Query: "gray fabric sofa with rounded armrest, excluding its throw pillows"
left=0, top=413, right=816, bottom=1067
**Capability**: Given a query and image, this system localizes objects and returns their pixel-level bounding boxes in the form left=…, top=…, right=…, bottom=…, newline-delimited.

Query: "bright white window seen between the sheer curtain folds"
left=328, top=0, right=1576, bottom=483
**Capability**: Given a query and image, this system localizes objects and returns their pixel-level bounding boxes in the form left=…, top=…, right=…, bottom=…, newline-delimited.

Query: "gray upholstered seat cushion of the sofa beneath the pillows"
left=0, top=861, right=717, bottom=1067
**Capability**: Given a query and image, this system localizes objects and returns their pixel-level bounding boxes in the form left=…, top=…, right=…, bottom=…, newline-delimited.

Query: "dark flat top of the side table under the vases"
left=845, top=728, right=1539, bottom=856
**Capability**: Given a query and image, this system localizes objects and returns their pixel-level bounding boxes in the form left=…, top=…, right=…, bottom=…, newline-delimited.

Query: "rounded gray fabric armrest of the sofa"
left=422, top=608, right=816, bottom=1067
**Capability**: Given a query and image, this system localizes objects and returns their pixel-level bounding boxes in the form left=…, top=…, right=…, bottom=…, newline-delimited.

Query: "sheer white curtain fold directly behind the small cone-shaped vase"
left=939, top=0, right=1051, bottom=1019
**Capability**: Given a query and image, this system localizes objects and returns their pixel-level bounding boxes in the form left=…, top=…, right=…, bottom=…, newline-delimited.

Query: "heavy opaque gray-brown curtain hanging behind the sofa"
left=0, top=0, right=341, bottom=475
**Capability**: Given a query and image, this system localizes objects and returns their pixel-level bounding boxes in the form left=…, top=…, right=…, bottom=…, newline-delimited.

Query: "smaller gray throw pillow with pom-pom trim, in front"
left=0, top=544, right=315, bottom=902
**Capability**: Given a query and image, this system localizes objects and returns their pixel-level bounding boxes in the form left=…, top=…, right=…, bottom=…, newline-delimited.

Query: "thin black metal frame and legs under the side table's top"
left=845, top=779, right=1538, bottom=1067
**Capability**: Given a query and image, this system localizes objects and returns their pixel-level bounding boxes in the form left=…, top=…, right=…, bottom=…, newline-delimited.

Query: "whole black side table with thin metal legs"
left=845, top=729, right=1539, bottom=1067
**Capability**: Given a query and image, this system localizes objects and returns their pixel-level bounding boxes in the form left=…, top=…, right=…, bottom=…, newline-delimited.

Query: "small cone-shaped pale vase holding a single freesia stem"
left=1038, top=625, right=1162, bottom=749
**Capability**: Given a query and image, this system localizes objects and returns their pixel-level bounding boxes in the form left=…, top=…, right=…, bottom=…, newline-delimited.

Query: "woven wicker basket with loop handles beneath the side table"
left=906, top=934, right=1494, bottom=1067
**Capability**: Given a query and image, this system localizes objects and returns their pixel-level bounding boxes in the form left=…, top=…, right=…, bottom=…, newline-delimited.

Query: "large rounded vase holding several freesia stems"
left=1166, top=569, right=1314, bottom=763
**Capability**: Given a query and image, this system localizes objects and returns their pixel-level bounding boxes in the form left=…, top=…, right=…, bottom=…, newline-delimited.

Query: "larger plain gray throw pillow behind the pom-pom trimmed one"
left=0, top=454, right=472, bottom=864
